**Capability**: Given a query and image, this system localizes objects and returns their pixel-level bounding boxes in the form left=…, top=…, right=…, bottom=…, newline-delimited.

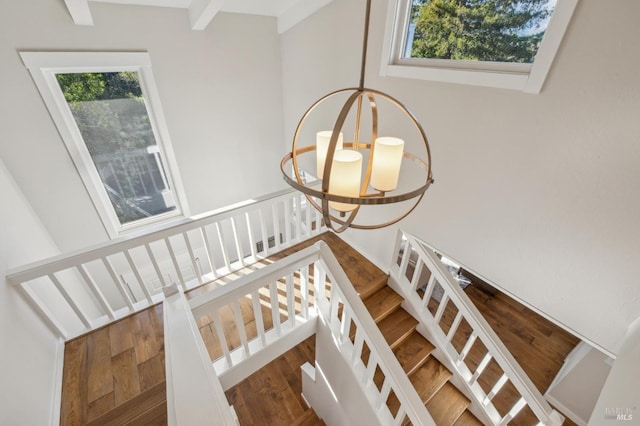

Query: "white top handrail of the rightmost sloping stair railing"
left=397, top=231, right=561, bottom=424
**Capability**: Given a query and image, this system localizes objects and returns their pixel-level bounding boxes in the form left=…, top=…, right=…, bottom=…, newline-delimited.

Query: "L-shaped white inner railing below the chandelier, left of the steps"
left=185, top=242, right=435, bottom=426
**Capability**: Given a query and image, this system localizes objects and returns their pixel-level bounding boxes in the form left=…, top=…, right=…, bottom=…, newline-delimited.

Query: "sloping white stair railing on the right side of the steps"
left=390, top=231, right=564, bottom=425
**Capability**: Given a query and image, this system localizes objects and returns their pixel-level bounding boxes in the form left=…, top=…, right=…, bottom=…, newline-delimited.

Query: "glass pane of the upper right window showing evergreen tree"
left=403, top=0, right=556, bottom=63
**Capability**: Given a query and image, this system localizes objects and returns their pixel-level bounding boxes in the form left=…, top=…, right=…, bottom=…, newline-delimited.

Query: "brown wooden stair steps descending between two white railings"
left=364, top=285, right=482, bottom=426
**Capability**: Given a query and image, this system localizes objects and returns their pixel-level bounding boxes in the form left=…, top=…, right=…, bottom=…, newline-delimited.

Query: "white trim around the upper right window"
left=380, top=0, right=578, bottom=93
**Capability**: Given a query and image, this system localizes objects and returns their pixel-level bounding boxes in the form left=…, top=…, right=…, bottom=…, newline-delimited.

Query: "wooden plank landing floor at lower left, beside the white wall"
left=60, top=304, right=166, bottom=425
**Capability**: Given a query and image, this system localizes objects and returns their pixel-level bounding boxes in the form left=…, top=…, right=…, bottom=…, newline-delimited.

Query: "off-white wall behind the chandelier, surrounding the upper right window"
left=281, top=0, right=640, bottom=353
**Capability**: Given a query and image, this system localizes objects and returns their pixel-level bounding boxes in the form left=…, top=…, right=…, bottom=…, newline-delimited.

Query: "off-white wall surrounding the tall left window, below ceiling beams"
left=0, top=0, right=282, bottom=251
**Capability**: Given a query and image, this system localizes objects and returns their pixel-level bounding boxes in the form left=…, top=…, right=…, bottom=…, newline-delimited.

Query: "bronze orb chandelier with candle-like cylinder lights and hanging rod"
left=280, top=0, right=433, bottom=232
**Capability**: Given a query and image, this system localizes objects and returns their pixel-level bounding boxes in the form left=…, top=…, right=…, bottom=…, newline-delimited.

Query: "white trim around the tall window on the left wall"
left=20, top=52, right=189, bottom=238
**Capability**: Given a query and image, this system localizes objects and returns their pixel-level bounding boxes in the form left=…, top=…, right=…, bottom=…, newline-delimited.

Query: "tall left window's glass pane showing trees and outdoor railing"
left=56, top=72, right=176, bottom=224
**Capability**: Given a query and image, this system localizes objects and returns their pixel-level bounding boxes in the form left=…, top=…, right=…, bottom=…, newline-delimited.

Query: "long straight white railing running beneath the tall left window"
left=7, top=190, right=325, bottom=339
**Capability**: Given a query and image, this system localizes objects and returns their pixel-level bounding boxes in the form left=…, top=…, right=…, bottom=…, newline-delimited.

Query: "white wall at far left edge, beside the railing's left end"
left=0, top=160, right=63, bottom=426
